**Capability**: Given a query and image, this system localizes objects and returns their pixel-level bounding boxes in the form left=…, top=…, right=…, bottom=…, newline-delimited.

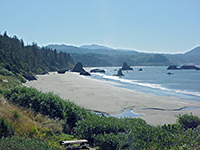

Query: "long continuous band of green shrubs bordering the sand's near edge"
left=1, top=87, right=200, bottom=150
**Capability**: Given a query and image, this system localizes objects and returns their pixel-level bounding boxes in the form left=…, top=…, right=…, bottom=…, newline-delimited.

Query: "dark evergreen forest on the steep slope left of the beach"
left=0, top=32, right=73, bottom=74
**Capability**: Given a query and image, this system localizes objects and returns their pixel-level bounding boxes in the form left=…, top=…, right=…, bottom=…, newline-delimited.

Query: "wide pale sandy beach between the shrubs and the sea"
left=24, top=72, right=200, bottom=125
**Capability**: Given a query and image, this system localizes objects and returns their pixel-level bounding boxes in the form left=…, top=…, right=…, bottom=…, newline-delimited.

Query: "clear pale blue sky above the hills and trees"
left=0, top=0, right=200, bottom=54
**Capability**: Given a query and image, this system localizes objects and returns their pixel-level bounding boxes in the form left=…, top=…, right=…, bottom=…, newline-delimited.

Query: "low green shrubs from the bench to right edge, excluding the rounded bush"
left=75, top=114, right=200, bottom=150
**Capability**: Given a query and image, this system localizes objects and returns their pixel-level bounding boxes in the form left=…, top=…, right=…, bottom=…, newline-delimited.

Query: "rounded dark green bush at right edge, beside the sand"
left=178, top=113, right=200, bottom=129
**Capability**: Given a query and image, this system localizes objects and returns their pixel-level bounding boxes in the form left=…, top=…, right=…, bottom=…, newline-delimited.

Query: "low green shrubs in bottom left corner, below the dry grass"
left=0, top=136, right=59, bottom=150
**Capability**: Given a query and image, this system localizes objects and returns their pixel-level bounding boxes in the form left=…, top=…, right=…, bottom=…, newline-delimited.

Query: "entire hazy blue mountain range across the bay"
left=47, top=44, right=200, bottom=67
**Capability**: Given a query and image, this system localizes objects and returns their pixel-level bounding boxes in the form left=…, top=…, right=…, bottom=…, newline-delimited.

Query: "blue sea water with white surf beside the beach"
left=87, top=66, right=200, bottom=101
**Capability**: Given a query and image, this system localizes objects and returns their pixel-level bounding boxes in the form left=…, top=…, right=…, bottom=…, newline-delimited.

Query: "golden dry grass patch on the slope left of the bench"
left=0, top=97, right=74, bottom=148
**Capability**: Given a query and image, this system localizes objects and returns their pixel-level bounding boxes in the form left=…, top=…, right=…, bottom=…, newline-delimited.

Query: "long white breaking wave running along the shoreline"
left=92, top=73, right=200, bottom=96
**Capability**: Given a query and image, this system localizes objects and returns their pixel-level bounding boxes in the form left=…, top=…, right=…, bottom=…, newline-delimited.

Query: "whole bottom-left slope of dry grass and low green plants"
left=0, top=94, right=74, bottom=150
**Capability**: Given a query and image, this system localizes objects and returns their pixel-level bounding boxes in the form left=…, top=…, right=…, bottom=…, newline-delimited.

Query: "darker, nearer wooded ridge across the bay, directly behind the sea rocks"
left=71, top=53, right=171, bottom=67
